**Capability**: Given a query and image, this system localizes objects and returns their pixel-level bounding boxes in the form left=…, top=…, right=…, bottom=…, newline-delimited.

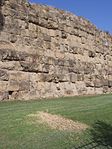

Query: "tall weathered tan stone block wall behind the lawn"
left=0, top=0, right=112, bottom=100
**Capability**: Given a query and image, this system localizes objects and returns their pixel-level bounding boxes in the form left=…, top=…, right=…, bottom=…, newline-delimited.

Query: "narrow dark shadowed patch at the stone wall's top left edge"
left=0, top=0, right=5, bottom=31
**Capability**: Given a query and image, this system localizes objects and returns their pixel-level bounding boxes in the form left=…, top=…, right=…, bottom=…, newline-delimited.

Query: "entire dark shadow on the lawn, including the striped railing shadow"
left=72, top=121, right=112, bottom=149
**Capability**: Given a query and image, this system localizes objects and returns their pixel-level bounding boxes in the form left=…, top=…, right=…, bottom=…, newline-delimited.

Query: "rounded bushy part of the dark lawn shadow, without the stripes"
left=90, top=121, right=112, bottom=147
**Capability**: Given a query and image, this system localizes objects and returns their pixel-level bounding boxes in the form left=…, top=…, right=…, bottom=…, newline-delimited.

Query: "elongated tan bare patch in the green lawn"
left=28, top=112, right=89, bottom=132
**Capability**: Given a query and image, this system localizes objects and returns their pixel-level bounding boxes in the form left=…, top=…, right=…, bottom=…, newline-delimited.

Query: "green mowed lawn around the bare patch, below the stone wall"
left=0, top=95, right=112, bottom=149
